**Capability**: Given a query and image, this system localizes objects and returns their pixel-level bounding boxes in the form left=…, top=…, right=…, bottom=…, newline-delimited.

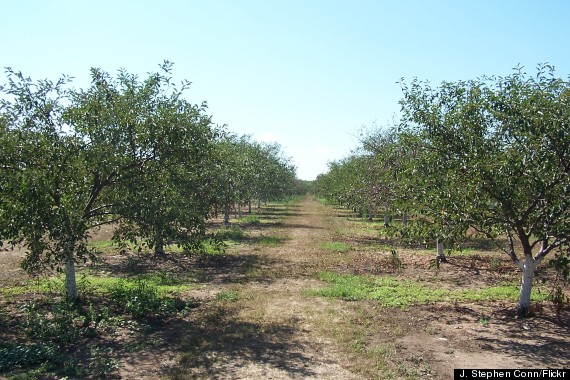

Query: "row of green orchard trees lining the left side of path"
left=0, top=62, right=300, bottom=300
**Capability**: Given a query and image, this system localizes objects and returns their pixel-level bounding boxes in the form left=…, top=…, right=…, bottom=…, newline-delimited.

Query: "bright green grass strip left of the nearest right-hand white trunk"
left=312, top=272, right=546, bottom=308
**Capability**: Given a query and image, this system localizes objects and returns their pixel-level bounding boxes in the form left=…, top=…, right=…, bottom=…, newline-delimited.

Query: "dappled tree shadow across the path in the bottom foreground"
left=163, top=307, right=315, bottom=379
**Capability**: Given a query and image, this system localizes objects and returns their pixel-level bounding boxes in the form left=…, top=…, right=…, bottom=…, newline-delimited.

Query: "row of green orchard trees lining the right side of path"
left=315, top=65, right=570, bottom=316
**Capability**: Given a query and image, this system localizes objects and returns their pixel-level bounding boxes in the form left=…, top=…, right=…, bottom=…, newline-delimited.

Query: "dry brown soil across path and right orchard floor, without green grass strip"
left=0, top=198, right=570, bottom=379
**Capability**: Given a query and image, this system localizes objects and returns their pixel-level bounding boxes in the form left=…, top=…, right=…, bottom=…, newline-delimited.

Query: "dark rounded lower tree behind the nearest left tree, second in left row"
left=110, top=151, right=215, bottom=256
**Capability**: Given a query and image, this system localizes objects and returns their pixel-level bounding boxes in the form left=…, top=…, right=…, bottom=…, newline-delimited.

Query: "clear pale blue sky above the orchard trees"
left=0, top=0, right=570, bottom=179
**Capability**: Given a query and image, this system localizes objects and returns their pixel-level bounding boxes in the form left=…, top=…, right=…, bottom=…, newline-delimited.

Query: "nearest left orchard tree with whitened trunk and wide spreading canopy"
left=0, top=62, right=217, bottom=300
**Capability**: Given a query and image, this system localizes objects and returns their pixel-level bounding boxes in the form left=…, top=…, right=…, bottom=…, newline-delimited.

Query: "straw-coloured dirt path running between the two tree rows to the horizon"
left=164, top=199, right=361, bottom=379
